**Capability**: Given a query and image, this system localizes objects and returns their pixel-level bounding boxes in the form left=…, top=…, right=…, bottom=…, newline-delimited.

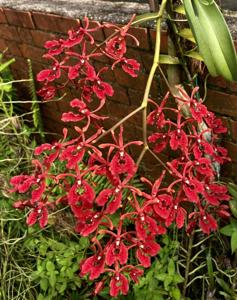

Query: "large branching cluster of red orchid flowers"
left=10, top=18, right=229, bottom=297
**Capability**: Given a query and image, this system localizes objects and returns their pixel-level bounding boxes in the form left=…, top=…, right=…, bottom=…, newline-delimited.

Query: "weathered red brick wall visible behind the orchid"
left=0, top=8, right=237, bottom=181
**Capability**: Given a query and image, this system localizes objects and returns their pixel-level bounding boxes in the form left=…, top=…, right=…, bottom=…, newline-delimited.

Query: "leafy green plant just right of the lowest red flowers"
left=134, top=235, right=181, bottom=300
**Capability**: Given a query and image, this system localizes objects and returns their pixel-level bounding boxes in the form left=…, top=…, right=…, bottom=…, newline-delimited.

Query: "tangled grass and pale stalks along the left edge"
left=0, top=55, right=37, bottom=300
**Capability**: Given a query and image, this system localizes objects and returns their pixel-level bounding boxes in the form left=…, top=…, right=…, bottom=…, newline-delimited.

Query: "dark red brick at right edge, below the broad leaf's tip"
left=205, top=90, right=237, bottom=117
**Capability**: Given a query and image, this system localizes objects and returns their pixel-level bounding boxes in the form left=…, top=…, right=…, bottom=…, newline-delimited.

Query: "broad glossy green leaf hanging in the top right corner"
left=184, top=0, right=237, bottom=80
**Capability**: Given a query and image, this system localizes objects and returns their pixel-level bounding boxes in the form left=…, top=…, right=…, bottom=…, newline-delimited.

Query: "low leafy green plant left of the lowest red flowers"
left=25, top=228, right=89, bottom=300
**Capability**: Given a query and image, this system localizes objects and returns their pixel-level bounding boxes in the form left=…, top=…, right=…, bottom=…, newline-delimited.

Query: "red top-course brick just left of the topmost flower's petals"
left=33, top=12, right=79, bottom=33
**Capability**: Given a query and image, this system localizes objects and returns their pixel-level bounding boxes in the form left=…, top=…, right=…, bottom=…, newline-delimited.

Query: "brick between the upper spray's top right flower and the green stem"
left=127, top=27, right=150, bottom=50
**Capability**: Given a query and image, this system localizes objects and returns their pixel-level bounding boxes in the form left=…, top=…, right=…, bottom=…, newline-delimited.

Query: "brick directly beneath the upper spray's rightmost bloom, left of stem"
left=114, top=68, right=147, bottom=91
